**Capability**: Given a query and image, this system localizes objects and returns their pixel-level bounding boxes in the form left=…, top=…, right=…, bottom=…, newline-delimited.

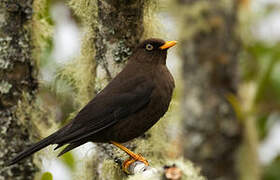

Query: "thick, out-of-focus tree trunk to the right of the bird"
left=177, top=0, right=241, bottom=180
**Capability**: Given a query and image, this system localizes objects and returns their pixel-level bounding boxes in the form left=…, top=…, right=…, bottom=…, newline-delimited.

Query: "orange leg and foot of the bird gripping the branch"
left=111, top=141, right=149, bottom=174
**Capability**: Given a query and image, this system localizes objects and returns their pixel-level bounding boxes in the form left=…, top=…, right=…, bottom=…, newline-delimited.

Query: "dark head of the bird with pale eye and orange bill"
left=132, top=38, right=177, bottom=64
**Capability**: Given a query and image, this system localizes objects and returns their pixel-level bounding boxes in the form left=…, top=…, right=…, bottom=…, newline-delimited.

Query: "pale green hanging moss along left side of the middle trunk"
left=57, top=0, right=96, bottom=107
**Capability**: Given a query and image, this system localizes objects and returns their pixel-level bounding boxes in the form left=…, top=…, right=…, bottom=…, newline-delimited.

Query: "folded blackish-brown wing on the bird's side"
left=54, top=77, right=154, bottom=147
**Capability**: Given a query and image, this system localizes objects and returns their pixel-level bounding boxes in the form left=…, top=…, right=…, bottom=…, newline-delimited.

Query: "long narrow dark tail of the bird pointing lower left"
left=7, top=132, right=58, bottom=166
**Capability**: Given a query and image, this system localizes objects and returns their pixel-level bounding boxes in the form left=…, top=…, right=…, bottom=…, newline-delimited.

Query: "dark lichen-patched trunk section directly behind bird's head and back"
left=95, top=0, right=144, bottom=84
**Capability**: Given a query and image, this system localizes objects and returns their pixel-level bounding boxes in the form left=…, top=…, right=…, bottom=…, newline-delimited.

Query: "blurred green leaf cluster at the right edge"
left=241, top=41, right=280, bottom=139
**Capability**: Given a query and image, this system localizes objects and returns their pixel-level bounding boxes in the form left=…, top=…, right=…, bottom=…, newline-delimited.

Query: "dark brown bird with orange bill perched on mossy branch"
left=9, top=39, right=176, bottom=170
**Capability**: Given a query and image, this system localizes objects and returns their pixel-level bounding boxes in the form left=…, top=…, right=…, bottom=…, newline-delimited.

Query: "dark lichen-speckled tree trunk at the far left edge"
left=0, top=0, right=38, bottom=180
